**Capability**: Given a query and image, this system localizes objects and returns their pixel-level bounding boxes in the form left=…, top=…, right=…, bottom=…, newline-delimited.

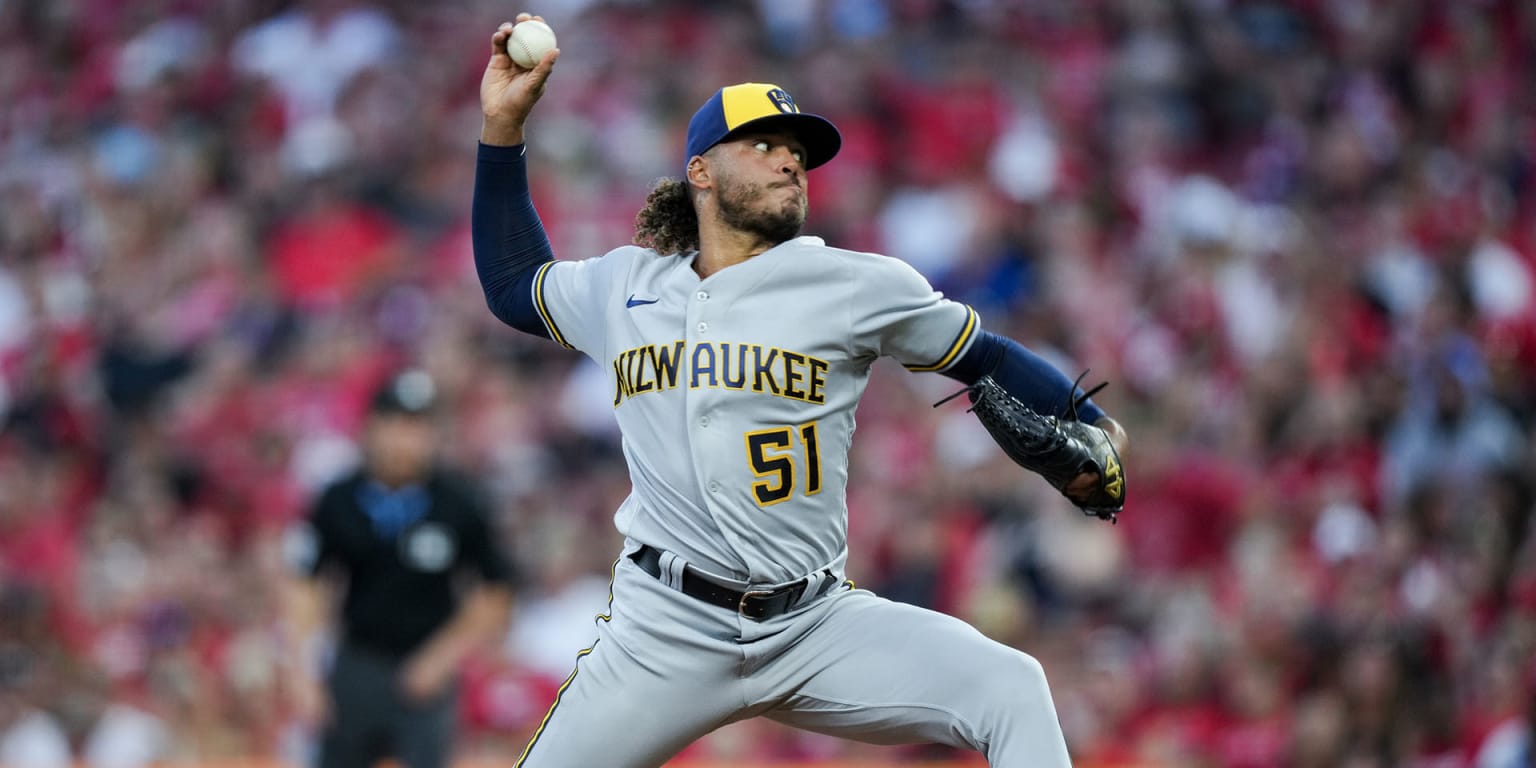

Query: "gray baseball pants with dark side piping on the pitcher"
left=516, top=558, right=1072, bottom=768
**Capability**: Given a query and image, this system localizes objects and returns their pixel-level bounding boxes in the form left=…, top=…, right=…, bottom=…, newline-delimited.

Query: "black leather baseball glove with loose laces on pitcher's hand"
left=935, top=376, right=1126, bottom=522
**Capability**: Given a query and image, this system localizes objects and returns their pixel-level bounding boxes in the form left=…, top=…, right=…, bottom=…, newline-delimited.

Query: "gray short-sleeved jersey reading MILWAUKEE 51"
left=535, top=237, right=977, bottom=584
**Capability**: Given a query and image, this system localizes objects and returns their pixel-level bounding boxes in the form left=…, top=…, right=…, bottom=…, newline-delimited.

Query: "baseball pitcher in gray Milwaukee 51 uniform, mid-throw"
left=473, top=14, right=1126, bottom=768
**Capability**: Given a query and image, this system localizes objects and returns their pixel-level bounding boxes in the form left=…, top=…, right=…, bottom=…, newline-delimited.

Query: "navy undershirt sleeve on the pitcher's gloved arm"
left=943, top=330, right=1104, bottom=424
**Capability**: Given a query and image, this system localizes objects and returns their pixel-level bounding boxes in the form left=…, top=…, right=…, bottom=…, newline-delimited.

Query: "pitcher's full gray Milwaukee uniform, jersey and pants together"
left=518, top=237, right=1071, bottom=768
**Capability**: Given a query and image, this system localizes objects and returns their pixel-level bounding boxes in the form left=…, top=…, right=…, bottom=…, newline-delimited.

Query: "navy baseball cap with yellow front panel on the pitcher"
left=684, top=83, right=843, bottom=170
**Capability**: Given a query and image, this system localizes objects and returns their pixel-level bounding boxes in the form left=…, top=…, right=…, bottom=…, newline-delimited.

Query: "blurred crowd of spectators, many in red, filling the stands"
left=0, top=0, right=1536, bottom=768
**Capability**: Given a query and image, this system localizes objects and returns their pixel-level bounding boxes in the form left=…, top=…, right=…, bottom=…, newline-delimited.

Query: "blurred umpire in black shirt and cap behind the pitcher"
left=287, top=370, right=513, bottom=768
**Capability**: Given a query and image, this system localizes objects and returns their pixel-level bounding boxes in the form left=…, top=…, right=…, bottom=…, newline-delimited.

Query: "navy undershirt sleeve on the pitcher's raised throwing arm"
left=470, top=144, right=554, bottom=338
